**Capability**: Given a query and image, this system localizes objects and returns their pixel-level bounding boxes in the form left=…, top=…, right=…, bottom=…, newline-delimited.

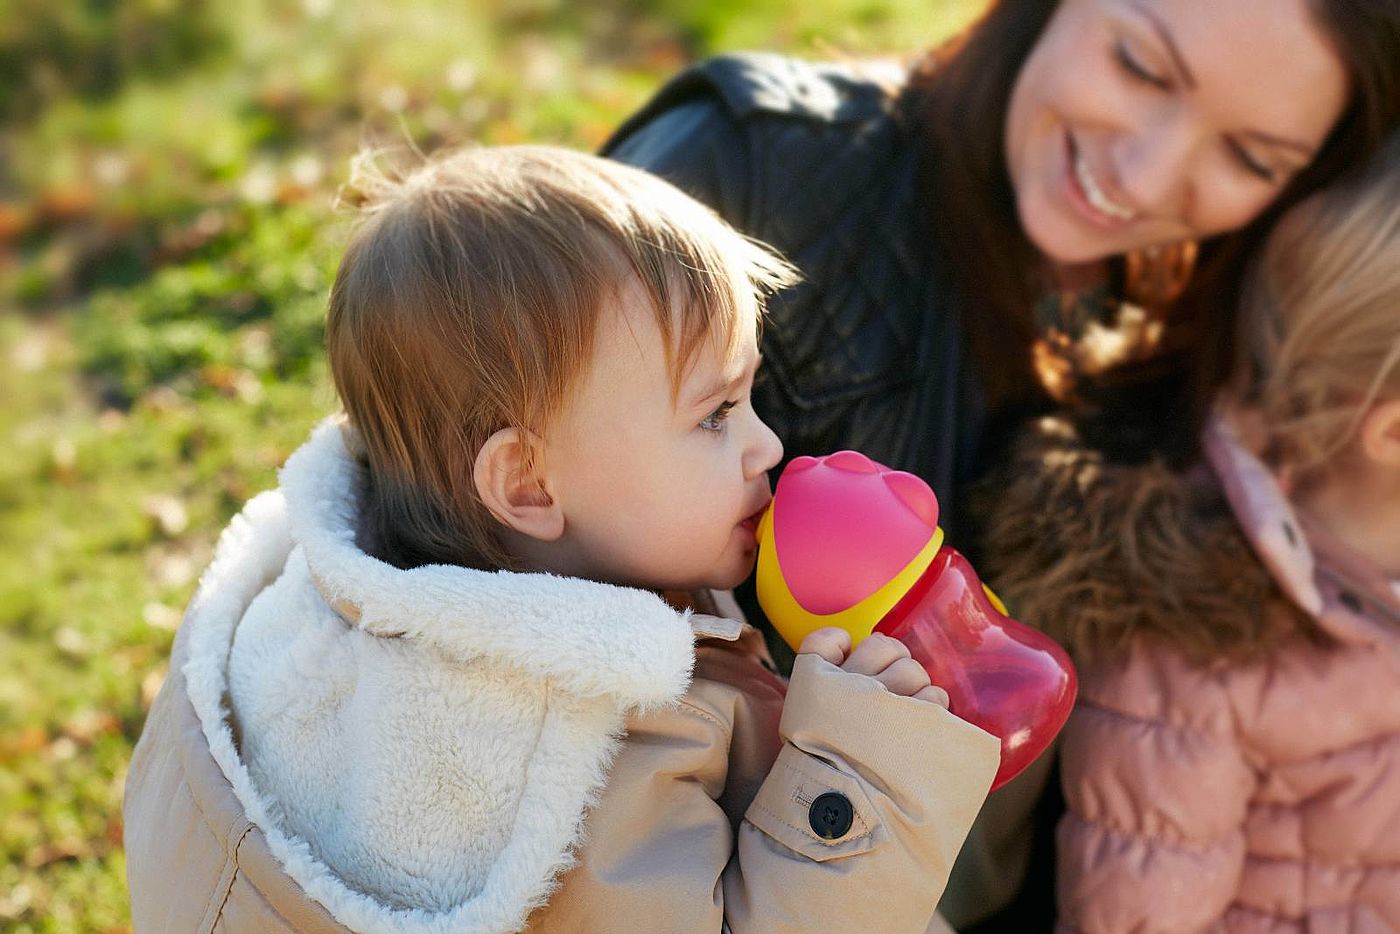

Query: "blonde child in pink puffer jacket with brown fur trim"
left=988, top=131, right=1400, bottom=933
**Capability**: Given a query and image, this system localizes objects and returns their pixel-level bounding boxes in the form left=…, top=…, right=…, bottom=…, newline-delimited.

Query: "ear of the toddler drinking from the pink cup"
left=472, top=428, right=564, bottom=542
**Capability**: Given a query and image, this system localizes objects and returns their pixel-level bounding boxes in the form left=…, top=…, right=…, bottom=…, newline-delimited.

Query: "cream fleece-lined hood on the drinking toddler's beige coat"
left=183, top=420, right=694, bottom=934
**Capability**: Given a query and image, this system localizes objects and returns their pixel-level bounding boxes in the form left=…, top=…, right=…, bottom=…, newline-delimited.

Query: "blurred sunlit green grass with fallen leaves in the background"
left=0, top=0, right=980, bottom=931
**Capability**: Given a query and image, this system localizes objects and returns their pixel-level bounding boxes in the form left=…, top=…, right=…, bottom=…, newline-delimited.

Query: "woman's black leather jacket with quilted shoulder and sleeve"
left=603, top=55, right=984, bottom=542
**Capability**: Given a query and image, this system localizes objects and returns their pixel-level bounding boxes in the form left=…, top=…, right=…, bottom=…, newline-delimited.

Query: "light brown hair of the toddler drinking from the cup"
left=326, top=147, right=795, bottom=569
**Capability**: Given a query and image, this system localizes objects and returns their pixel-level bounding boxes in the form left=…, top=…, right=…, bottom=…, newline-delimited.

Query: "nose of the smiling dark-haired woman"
left=1112, top=115, right=1198, bottom=220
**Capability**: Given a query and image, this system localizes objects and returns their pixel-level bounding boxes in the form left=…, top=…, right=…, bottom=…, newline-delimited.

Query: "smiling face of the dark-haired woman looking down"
left=1005, top=0, right=1348, bottom=263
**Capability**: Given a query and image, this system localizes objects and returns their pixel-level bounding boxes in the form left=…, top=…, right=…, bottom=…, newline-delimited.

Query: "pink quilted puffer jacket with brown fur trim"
left=991, top=421, right=1400, bottom=934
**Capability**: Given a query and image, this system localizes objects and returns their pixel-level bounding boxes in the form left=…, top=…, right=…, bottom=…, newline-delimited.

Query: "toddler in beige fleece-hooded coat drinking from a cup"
left=126, top=147, right=1000, bottom=933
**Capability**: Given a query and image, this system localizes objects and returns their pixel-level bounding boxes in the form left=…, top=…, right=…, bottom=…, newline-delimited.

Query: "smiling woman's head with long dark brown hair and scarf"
left=906, top=0, right=1400, bottom=445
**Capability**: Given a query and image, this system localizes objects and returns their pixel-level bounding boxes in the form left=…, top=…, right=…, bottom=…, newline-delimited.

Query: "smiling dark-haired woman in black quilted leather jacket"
left=605, top=0, right=1400, bottom=930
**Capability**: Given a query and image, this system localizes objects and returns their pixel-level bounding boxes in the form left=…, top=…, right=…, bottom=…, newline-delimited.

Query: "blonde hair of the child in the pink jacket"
left=1240, top=134, right=1400, bottom=482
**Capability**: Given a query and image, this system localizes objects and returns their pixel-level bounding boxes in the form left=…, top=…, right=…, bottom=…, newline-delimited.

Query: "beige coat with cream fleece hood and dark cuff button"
left=125, top=420, right=998, bottom=931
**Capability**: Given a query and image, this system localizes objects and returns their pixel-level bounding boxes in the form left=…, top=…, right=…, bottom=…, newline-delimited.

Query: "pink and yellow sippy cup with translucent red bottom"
left=757, top=451, right=1078, bottom=790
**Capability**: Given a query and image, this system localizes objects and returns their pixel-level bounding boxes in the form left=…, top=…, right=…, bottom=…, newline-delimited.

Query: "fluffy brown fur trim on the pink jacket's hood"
left=973, top=417, right=1320, bottom=667
